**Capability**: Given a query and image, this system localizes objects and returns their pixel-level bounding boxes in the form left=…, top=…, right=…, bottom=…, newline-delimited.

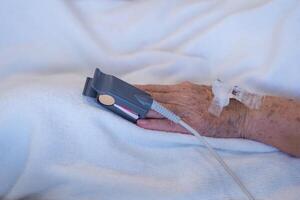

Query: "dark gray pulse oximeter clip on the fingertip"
left=83, top=68, right=153, bottom=123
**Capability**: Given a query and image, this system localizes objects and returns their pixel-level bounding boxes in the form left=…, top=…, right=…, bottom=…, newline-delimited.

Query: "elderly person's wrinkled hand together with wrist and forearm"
left=137, top=82, right=300, bottom=157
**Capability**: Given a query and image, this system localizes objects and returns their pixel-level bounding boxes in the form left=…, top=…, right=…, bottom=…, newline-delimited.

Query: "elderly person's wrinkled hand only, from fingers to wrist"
left=137, top=82, right=247, bottom=138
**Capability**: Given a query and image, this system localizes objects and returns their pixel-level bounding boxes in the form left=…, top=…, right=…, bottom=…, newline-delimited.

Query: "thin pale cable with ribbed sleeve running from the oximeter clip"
left=151, top=100, right=255, bottom=200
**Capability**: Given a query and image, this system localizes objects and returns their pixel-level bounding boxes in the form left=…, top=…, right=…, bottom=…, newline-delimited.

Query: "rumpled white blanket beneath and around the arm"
left=0, top=0, right=300, bottom=200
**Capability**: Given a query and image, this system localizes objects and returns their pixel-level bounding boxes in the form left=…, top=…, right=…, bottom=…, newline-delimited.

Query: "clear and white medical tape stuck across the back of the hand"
left=208, top=79, right=263, bottom=117
